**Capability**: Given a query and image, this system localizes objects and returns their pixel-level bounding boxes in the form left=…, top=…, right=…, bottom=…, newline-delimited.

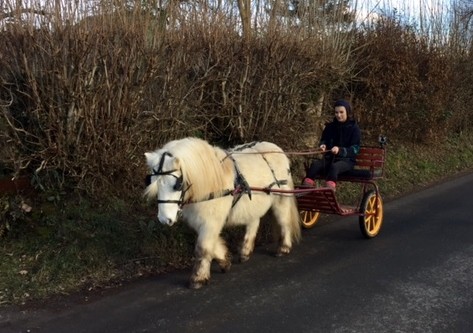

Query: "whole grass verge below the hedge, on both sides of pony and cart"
left=0, top=134, right=473, bottom=305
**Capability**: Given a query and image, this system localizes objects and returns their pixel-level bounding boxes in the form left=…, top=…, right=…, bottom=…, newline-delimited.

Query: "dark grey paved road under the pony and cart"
left=0, top=174, right=473, bottom=333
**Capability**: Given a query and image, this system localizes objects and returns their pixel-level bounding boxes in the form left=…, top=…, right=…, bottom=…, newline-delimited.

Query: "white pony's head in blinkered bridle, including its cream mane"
left=145, top=138, right=234, bottom=225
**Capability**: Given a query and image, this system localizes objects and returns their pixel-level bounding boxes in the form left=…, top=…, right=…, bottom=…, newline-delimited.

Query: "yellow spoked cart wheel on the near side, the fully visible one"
left=359, top=190, right=383, bottom=238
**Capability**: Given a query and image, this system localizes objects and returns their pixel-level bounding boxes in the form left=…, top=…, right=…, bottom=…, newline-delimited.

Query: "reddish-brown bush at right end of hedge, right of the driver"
left=353, top=20, right=470, bottom=142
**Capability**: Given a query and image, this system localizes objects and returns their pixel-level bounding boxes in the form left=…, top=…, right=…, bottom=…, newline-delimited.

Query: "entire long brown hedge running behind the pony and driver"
left=0, top=3, right=472, bottom=198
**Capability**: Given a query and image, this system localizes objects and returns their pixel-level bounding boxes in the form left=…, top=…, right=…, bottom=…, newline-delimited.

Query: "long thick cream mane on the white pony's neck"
left=163, top=138, right=234, bottom=201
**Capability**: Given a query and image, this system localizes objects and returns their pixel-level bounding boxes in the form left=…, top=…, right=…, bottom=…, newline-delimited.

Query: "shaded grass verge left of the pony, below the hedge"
left=0, top=198, right=193, bottom=304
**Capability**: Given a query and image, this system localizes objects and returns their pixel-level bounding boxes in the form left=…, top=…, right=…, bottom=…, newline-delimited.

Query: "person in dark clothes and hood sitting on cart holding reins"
left=302, top=99, right=361, bottom=190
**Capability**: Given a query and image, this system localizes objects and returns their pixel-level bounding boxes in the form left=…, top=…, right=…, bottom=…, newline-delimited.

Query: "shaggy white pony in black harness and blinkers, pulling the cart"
left=145, top=138, right=301, bottom=289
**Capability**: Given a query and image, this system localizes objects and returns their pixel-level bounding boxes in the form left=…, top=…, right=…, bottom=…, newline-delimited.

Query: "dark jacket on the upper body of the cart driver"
left=319, top=118, right=361, bottom=162
